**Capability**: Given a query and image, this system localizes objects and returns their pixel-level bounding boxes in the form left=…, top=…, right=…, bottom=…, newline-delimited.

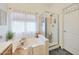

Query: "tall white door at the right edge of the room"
left=64, top=10, right=79, bottom=54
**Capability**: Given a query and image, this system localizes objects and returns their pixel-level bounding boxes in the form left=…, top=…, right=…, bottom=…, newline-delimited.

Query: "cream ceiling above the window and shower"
left=7, top=3, right=70, bottom=13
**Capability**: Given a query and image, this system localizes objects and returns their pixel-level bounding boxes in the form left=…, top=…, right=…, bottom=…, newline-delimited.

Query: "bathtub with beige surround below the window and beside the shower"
left=13, top=37, right=49, bottom=55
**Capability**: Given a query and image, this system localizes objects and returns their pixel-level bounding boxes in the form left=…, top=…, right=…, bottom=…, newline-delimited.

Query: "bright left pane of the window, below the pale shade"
left=11, top=21, right=24, bottom=33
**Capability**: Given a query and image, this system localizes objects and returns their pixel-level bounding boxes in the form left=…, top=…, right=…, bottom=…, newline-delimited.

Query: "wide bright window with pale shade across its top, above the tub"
left=11, top=13, right=37, bottom=34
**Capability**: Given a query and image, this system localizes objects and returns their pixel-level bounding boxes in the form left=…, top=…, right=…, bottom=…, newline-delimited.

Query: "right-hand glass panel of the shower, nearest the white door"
left=49, top=15, right=59, bottom=46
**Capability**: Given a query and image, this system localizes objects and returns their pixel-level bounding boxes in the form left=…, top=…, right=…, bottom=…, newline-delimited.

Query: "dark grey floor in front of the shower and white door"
left=49, top=48, right=72, bottom=55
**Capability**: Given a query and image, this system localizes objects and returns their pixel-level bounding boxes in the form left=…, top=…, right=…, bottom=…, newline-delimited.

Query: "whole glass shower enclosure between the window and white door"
left=41, top=14, right=59, bottom=47
